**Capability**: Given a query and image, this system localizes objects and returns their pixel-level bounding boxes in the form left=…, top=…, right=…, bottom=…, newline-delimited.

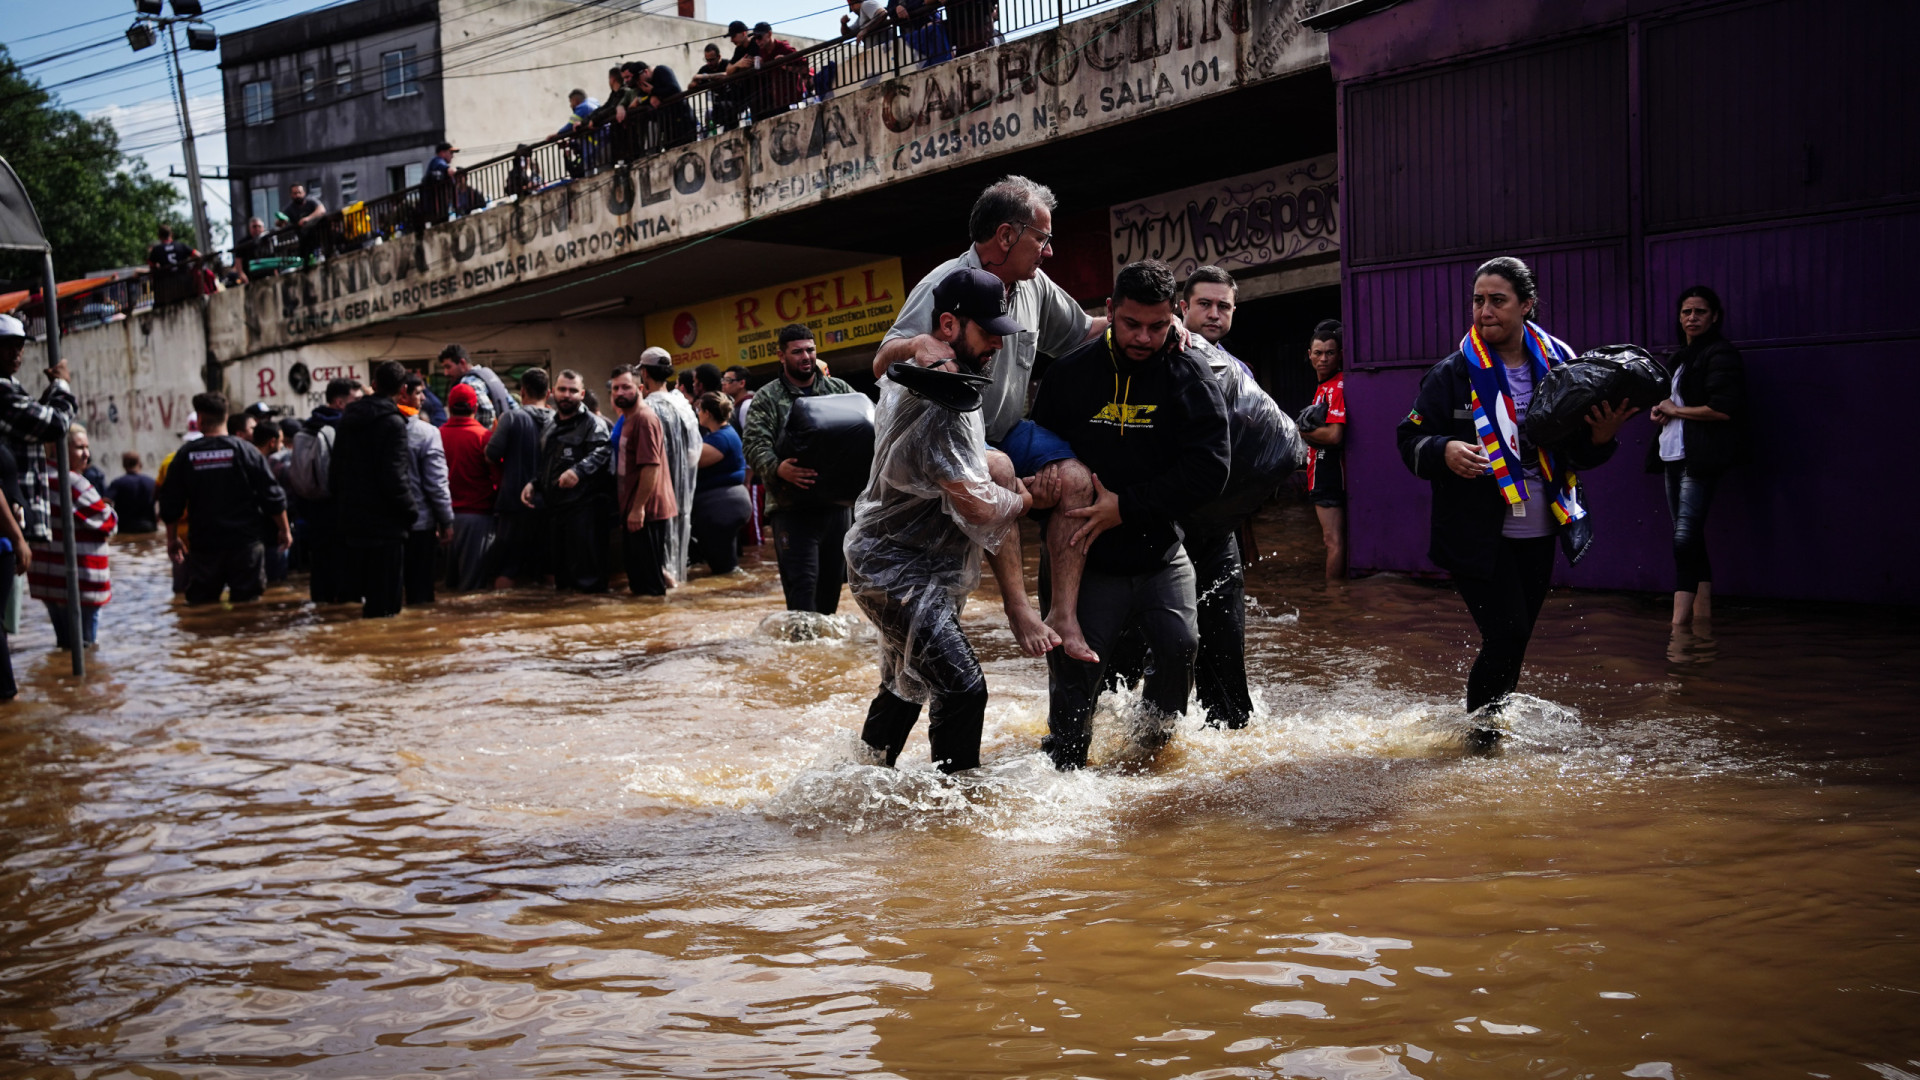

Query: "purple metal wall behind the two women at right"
left=1331, top=0, right=1920, bottom=603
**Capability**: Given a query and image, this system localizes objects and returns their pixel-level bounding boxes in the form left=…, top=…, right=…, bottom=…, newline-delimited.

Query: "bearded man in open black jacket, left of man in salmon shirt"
left=520, top=371, right=612, bottom=592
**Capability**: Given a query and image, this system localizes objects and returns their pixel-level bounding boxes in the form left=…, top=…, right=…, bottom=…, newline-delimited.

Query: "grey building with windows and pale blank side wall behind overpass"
left=221, top=0, right=732, bottom=236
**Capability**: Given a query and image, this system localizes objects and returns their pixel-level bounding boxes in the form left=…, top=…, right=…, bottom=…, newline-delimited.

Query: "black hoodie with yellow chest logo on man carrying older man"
left=1031, top=336, right=1231, bottom=575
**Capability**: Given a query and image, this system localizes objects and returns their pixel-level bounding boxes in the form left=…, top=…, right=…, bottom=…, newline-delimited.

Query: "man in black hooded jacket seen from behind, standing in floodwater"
left=328, top=359, right=417, bottom=619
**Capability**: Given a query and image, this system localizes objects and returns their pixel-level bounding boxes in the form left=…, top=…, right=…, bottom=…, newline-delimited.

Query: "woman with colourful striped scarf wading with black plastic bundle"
left=1396, top=258, right=1638, bottom=751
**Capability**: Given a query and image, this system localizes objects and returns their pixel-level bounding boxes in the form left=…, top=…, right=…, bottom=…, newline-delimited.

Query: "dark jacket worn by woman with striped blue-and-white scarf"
left=1394, top=352, right=1619, bottom=578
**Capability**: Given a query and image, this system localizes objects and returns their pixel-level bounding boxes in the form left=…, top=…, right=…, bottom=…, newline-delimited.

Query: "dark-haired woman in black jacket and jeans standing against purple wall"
left=1647, top=284, right=1747, bottom=626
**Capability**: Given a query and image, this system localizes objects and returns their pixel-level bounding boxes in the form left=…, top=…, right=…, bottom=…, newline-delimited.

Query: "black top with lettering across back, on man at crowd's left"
left=159, top=434, right=286, bottom=552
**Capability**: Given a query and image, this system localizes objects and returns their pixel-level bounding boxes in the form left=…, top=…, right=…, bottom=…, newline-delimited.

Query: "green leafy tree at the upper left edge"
left=0, top=46, right=194, bottom=284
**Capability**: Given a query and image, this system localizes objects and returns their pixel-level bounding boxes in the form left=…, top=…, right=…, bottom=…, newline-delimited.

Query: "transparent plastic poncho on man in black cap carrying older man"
left=847, top=379, right=1021, bottom=701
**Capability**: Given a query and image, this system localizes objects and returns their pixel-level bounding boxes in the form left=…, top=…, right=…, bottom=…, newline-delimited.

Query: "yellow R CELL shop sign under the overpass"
left=647, top=259, right=906, bottom=367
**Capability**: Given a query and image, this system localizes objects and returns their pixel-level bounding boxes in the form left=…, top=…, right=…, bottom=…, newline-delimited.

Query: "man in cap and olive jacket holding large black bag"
left=741, top=323, right=858, bottom=615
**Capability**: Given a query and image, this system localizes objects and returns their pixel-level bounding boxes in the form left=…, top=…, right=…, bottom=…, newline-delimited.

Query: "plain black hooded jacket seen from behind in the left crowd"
left=326, top=398, right=417, bottom=548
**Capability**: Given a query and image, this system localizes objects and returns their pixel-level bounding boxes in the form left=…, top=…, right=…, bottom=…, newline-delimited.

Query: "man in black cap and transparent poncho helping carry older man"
left=847, top=269, right=1039, bottom=773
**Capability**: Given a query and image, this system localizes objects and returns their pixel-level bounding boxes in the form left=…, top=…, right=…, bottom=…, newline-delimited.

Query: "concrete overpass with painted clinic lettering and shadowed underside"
left=41, top=0, right=1338, bottom=470
